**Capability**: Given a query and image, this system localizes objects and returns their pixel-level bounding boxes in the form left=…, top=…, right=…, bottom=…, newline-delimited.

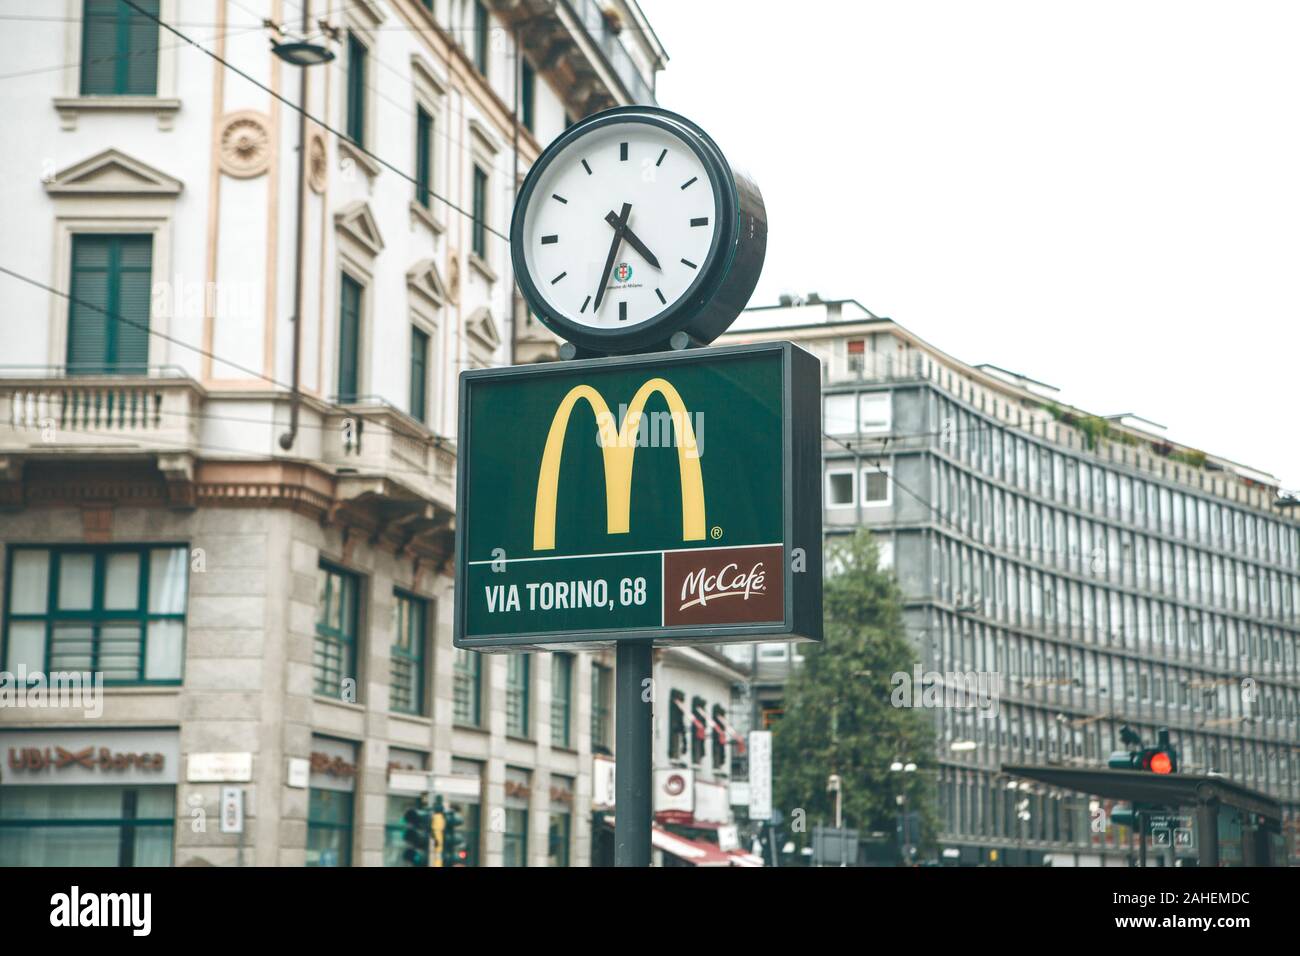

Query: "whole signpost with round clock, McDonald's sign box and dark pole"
left=454, top=108, right=822, bottom=866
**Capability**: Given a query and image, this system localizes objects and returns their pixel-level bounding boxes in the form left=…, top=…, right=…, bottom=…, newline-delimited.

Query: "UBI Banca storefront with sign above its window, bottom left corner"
left=0, top=728, right=179, bottom=866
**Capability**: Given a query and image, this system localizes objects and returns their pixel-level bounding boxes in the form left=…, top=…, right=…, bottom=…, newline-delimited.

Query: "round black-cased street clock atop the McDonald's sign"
left=510, top=107, right=767, bottom=355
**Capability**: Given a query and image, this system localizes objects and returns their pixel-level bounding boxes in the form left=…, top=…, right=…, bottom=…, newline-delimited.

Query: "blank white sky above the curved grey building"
left=640, top=0, right=1300, bottom=489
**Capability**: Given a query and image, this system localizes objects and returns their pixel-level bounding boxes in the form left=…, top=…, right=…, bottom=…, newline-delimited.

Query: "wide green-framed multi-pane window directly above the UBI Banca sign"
left=4, top=545, right=189, bottom=684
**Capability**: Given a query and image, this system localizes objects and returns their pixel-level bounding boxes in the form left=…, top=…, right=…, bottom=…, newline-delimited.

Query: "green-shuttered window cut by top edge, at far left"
left=81, top=0, right=159, bottom=96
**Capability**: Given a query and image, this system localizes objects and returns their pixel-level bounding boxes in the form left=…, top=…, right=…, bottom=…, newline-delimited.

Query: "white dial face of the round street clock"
left=523, top=122, right=719, bottom=329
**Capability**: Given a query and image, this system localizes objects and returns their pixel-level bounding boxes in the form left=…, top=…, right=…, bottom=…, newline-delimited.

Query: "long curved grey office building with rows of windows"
left=729, top=303, right=1300, bottom=864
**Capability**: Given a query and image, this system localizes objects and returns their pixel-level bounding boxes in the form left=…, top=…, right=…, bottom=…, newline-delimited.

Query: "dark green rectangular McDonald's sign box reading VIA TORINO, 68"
left=454, top=342, right=822, bottom=650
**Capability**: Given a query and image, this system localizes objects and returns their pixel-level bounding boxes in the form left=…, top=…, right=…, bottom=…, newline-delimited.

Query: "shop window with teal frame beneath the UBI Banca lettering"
left=0, top=786, right=176, bottom=866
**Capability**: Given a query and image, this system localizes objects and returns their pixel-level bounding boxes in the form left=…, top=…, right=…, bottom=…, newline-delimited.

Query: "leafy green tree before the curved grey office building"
left=772, top=529, right=935, bottom=847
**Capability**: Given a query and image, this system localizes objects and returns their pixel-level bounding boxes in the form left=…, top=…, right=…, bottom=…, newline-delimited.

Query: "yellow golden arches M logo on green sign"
left=533, top=378, right=706, bottom=551
